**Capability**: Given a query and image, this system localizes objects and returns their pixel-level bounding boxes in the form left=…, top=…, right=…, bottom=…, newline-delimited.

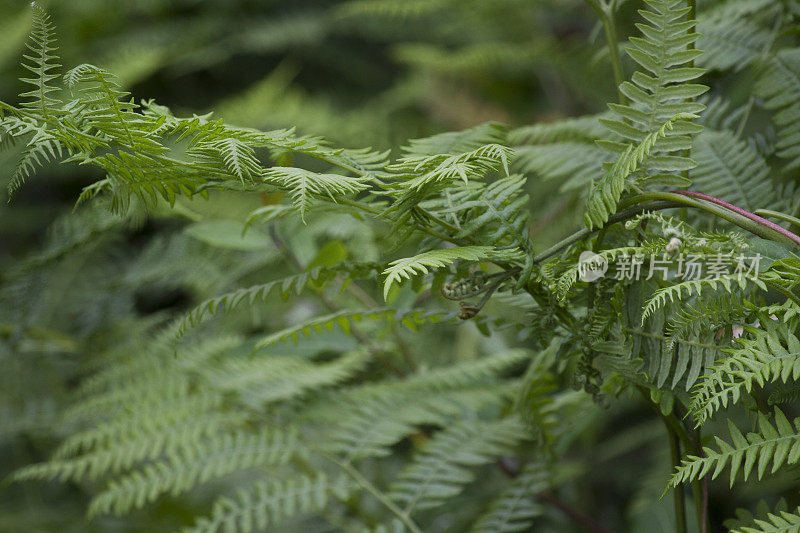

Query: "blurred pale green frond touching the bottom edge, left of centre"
left=183, top=472, right=351, bottom=533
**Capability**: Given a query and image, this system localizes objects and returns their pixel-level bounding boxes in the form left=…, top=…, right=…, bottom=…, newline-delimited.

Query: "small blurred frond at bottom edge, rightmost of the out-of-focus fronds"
left=470, top=462, right=550, bottom=533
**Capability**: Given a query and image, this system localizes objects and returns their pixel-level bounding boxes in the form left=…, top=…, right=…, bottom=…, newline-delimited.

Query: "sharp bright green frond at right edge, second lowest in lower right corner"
left=669, top=408, right=800, bottom=487
